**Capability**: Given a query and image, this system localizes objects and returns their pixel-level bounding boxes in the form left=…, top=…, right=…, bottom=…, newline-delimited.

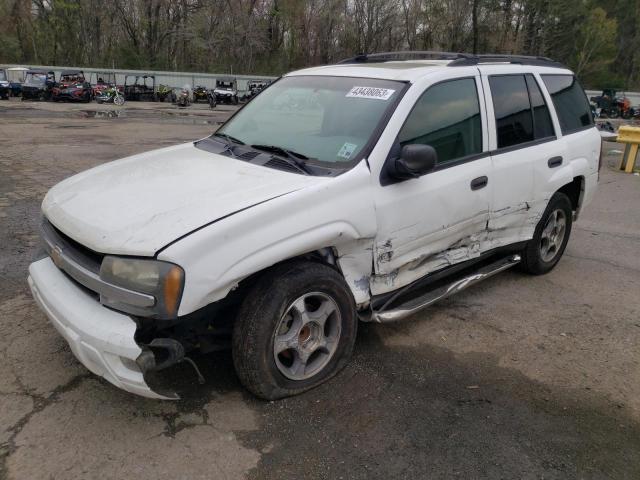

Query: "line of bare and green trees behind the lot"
left=0, top=0, right=640, bottom=89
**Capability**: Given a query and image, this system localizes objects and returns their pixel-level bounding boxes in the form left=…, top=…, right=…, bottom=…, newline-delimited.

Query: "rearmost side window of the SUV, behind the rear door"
left=542, top=75, right=593, bottom=135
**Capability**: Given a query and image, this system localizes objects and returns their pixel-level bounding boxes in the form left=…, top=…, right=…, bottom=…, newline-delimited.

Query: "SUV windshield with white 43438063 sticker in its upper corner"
left=217, top=76, right=403, bottom=164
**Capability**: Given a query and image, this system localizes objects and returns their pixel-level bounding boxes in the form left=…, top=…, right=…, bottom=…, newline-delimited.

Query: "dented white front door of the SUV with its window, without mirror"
left=371, top=74, right=493, bottom=295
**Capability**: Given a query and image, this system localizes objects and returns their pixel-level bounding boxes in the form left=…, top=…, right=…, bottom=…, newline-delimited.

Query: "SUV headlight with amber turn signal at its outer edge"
left=100, top=256, right=184, bottom=319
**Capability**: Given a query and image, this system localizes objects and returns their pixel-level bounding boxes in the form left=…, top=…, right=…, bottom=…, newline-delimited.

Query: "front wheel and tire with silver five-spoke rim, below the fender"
left=232, top=262, right=358, bottom=400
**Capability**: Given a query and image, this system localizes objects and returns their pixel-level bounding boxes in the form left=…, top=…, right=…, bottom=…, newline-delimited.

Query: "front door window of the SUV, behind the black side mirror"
left=398, top=78, right=482, bottom=165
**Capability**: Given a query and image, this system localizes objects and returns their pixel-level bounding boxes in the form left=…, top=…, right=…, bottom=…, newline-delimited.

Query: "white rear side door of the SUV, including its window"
left=480, top=66, right=564, bottom=248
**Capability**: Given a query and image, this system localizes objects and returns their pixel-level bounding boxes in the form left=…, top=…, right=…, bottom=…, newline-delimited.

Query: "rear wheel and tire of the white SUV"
left=520, top=192, right=573, bottom=275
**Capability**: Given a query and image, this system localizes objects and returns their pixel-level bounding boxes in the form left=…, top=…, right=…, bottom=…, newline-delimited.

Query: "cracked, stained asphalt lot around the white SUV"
left=0, top=100, right=640, bottom=480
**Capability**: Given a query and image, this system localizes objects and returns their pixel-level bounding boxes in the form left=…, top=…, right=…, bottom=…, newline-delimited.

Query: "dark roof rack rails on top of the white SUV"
left=338, top=50, right=566, bottom=68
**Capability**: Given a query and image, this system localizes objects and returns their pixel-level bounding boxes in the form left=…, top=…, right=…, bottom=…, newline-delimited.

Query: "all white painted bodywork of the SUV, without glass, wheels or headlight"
left=30, top=61, right=600, bottom=394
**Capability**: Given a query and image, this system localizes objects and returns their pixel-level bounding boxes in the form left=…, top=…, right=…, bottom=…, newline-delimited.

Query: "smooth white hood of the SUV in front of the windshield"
left=42, top=143, right=328, bottom=256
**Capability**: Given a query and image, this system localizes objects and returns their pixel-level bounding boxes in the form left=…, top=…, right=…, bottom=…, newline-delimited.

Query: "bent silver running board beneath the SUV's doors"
left=372, top=255, right=521, bottom=323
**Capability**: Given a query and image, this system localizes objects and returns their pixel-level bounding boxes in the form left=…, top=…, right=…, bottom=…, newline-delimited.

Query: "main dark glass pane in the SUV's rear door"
left=489, top=75, right=534, bottom=148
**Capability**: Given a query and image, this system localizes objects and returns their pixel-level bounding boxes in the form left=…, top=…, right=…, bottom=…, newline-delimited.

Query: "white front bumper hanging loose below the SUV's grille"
left=28, top=257, right=178, bottom=400
